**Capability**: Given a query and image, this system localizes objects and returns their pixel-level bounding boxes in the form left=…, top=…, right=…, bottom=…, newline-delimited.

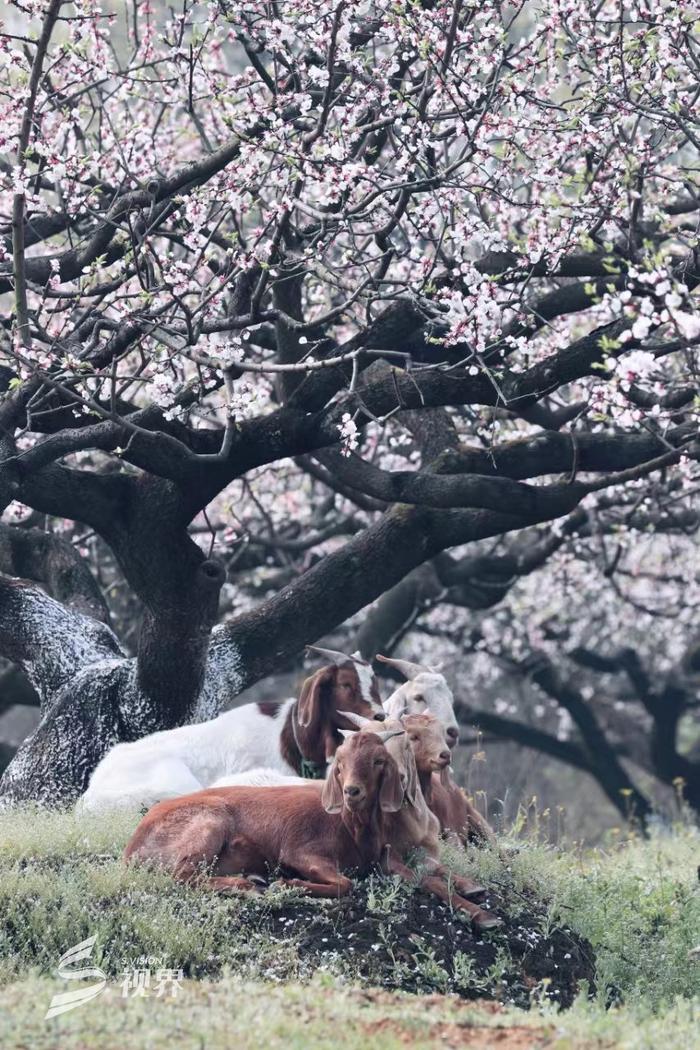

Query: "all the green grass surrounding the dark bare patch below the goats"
left=0, top=810, right=700, bottom=1050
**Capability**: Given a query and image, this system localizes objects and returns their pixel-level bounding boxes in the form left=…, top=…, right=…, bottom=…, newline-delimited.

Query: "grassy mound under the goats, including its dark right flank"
left=0, top=811, right=594, bottom=1006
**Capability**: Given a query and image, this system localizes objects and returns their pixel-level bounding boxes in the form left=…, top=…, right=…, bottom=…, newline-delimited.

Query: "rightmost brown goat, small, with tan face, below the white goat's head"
left=402, top=714, right=495, bottom=845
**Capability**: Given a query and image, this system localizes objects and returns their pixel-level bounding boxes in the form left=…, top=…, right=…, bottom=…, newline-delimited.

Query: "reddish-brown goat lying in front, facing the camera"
left=124, top=732, right=403, bottom=897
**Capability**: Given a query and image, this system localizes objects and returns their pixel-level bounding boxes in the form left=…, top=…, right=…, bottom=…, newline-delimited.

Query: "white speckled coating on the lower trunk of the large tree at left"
left=0, top=582, right=250, bottom=805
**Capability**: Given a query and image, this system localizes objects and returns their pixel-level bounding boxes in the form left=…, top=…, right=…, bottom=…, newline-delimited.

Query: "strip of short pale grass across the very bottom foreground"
left=0, top=977, right=700, bottom=1050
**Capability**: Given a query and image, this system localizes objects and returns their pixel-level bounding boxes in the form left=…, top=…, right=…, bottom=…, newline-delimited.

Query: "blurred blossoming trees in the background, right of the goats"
left=360, top=525, right=700, bottom=818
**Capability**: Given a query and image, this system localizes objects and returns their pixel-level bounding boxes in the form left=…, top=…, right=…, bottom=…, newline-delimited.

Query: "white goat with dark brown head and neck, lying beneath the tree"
left=79, top=646, right=385, bottom=811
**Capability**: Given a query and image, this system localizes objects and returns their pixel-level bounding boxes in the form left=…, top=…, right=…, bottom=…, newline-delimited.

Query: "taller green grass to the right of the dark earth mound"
left=450, top=824, right=700, bottom=1003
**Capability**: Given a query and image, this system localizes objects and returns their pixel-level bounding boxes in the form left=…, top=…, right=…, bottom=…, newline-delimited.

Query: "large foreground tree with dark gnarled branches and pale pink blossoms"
left=0, top=0, right=700, bottom=799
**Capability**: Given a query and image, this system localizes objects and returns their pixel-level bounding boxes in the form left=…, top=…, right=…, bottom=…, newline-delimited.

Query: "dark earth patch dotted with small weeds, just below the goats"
left=242, top=887, right=594, bottom=1007
